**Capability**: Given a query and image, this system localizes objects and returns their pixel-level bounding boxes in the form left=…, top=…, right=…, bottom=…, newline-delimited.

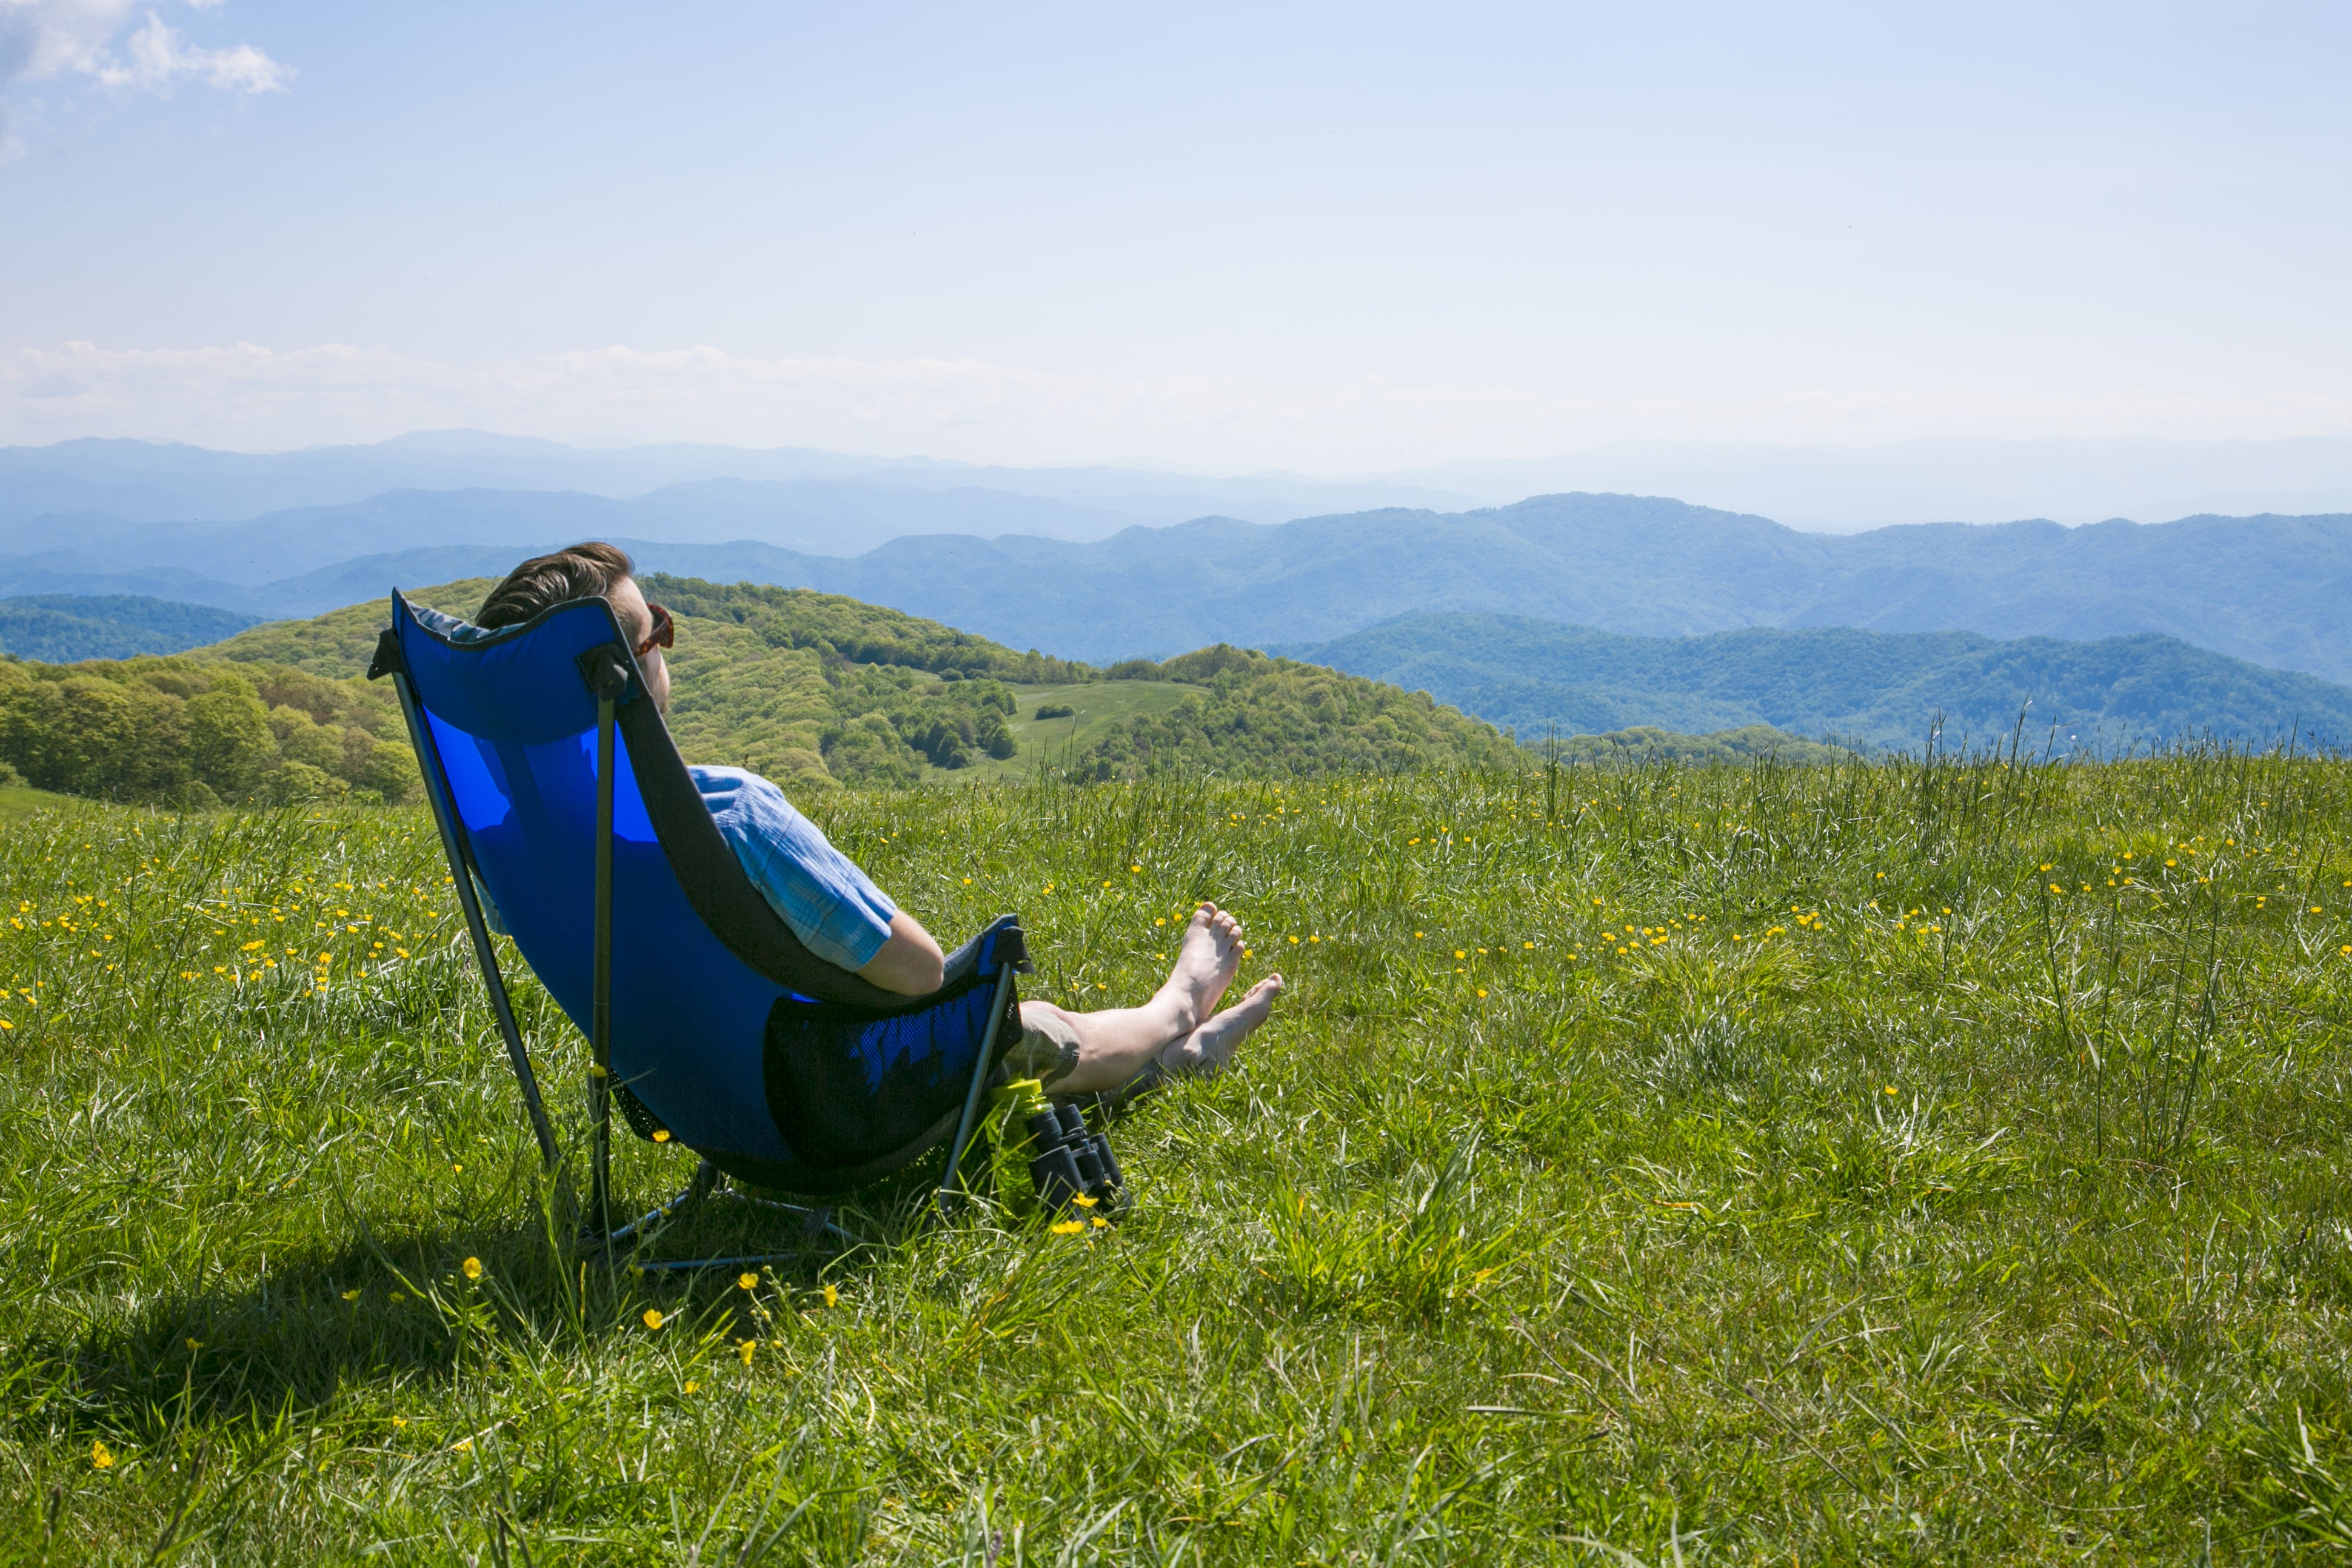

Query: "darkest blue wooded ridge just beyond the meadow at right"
left=1270, top=613, right=2352, bottom=752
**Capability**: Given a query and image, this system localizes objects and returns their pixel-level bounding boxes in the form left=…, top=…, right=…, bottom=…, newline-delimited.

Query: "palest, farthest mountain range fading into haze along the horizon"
left=18, top=430, right=2352, bottom=533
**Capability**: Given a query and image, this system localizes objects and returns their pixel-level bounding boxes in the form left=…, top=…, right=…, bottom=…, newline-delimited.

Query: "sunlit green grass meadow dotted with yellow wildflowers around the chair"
left=0, top=757, right=2352, bottom=1563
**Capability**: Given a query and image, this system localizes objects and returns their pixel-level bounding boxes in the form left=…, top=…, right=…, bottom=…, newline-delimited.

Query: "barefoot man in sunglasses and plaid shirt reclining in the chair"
left=475, top=543, right=1282, bottom=1095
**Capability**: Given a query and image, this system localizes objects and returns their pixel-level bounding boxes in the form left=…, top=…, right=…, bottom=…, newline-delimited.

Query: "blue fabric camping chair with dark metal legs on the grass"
left=367, top=590, right=1030, bottom=1267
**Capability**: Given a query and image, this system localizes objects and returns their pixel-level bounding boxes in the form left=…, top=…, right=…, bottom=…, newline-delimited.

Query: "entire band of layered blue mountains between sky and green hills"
left=18, top=430, right=2352, bottom=747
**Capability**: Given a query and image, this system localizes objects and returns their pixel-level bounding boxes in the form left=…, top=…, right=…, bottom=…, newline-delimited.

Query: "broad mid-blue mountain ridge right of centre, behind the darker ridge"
left=776, top=496, right=2352, bottom=679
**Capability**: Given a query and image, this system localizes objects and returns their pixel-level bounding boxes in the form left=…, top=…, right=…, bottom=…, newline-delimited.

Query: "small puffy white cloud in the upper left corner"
left=0, top=0, right=294, bottom=144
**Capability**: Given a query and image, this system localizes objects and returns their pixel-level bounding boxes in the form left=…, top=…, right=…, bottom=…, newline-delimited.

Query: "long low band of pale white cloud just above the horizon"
left=0, top=343, right=2352, bottom=473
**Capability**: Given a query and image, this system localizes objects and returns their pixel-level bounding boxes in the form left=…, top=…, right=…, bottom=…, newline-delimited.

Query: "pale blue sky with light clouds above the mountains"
left=0, top=0, right=2352, bottom=473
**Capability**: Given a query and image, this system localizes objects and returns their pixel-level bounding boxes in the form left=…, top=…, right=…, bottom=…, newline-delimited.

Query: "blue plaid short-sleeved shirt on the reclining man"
left=687, top=769, right=898, bottom=969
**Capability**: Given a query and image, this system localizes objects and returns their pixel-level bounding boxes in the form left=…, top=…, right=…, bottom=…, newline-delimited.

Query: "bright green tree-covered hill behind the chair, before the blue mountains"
left=0, top=573, right=1512, bottom=804
